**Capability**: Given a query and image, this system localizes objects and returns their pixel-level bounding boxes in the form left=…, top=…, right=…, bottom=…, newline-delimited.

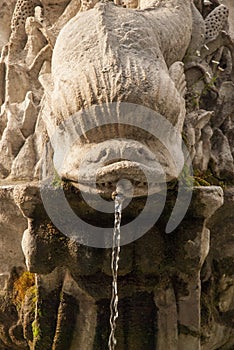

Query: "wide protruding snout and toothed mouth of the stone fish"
left=59, top=139, right=182, bottom=197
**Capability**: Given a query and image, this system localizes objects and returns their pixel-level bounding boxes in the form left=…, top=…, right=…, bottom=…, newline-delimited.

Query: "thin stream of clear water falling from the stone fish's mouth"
left=108, top=194, right=124, bottom=350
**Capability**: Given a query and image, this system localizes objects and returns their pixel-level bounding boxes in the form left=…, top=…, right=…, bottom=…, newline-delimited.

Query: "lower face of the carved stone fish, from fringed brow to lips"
left=44, top=102, right=184, bottom=197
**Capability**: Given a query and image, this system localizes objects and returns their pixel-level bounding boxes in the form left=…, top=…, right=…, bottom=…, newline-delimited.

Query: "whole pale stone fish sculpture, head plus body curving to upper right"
left=43, top=0, right=194, bottom=195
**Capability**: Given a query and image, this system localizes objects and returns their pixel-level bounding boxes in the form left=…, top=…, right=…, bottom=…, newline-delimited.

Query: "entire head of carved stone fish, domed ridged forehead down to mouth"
left=39, top=4, right=185, bottom=196
